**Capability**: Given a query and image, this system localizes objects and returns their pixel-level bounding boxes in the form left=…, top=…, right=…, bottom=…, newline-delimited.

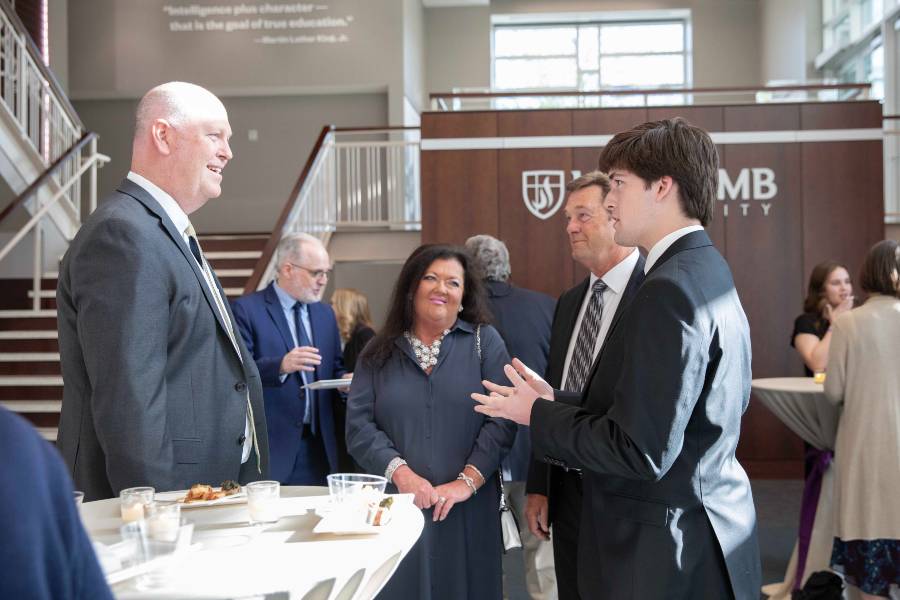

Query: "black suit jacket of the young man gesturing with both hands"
left=531, top=231, right=760, bottom=600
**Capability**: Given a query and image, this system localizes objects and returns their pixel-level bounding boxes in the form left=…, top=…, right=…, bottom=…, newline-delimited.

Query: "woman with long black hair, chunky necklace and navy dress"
left=347, top=245, right=516, bottom=600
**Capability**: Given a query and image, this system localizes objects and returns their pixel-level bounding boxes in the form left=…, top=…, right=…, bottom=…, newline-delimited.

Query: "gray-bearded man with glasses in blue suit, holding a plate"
left=233, top=233, right=344, bottom=485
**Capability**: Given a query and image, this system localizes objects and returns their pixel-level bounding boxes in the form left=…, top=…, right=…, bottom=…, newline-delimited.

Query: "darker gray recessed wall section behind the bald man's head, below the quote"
left=75, top=94, right=387, bottom=233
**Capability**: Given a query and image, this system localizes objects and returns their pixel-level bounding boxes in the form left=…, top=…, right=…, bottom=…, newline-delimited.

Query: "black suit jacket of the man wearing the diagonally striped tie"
left=525, top=255, right=644, bottom=523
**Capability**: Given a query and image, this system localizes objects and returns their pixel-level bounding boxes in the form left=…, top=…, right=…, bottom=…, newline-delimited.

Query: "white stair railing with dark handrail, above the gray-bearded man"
left=244, top=125, right=422, bottom=294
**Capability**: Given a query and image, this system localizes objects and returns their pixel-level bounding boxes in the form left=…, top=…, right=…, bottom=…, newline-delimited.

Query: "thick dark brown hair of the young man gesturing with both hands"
left=600, top=117, right=719, bottom=227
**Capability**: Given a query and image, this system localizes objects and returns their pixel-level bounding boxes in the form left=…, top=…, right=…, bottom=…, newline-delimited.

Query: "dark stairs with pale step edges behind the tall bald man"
left=0, top=234, right=269, bottom=441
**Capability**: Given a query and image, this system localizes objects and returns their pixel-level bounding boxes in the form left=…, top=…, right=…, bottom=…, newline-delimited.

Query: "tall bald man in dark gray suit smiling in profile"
left=56, top=82, right=268, bottom=500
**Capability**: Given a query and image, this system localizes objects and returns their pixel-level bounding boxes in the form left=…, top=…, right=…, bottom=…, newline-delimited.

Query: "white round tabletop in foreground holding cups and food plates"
left=81, top=486, right=424, bottom=600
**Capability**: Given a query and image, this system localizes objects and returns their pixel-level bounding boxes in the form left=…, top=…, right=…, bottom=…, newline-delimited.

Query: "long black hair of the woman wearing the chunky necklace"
left=362, top=244, right=491, bottom=367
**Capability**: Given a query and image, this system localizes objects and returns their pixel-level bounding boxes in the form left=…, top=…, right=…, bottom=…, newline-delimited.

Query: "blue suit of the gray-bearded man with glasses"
left=232, top=283, right=344, bottom=481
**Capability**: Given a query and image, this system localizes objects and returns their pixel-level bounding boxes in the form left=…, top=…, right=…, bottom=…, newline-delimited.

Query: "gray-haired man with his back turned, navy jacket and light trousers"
left=466, top=235, right=556, bottom=600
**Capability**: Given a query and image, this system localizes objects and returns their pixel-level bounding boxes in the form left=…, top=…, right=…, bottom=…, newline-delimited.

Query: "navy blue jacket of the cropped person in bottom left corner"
left=0, top=407, right=112, bottom=600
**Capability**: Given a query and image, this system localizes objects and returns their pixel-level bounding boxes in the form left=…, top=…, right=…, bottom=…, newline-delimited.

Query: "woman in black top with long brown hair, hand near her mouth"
left=791, top=260, right=853, bottom=377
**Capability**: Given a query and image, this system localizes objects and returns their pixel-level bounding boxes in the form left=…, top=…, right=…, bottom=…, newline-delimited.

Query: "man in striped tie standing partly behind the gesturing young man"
left=510, top=171, right=644, bottom=600
